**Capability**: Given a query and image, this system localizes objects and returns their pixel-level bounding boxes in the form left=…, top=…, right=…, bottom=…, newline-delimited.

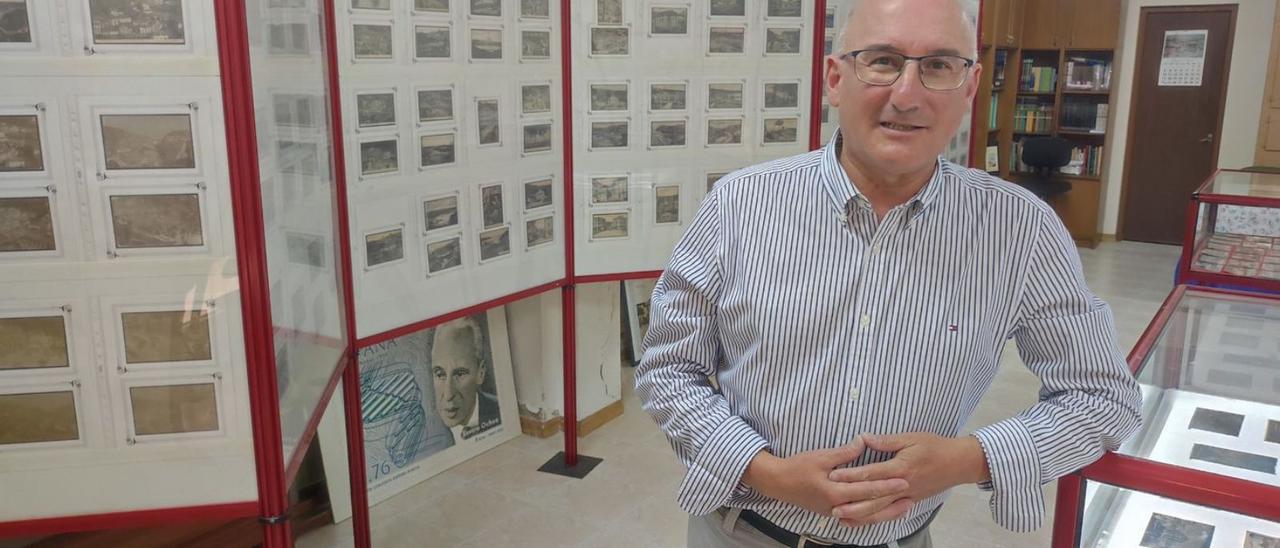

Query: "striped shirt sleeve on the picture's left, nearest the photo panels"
left=636, top=192, right=768, bottom=515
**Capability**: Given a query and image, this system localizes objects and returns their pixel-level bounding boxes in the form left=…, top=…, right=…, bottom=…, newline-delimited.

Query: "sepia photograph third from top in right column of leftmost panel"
left=105, top=187, right=210, bottom=256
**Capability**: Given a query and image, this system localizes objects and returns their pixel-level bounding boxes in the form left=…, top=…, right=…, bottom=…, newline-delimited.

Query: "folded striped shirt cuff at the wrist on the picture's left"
left=677, top=416, right=769, bottom=516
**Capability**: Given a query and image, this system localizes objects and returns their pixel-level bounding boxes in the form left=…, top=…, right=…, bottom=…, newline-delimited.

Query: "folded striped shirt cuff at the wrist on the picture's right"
left=973, top=417, right=1044, bottom=533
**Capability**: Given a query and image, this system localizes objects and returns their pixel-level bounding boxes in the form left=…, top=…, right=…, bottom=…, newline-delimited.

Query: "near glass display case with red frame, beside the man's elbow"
left=1053, top=286, right=1280, bottom=548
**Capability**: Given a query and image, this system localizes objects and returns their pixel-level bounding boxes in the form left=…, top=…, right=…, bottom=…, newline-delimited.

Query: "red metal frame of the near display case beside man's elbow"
left=1052, top=284, right=1280, bottom=548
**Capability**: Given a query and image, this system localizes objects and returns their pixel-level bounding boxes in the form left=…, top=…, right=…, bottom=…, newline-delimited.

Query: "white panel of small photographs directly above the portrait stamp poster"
left=337, top=0, right=565, bottom=338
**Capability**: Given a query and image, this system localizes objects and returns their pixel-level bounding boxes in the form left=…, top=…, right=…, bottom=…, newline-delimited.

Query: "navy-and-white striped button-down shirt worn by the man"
left=636, top=133, right=1140, bottom=544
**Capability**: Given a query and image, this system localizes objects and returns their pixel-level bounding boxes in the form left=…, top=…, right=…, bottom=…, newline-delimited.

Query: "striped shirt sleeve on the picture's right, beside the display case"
left=974, top=209, right=1142, bottom=531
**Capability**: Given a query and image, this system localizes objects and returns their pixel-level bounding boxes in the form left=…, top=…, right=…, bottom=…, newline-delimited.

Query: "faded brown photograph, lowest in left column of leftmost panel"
left=0, top=391, right=79, bottom=447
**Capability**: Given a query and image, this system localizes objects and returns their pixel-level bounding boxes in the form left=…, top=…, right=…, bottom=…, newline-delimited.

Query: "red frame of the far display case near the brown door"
left=1178, top=169, right=1280, bottom=293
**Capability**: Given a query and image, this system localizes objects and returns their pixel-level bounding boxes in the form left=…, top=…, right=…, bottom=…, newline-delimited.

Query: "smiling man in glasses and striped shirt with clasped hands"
left=636, top=0, right=1140, bottom=547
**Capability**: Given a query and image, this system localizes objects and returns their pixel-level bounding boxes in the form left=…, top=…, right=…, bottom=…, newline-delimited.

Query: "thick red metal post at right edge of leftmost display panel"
left=214, top=1, right=293, bottom=548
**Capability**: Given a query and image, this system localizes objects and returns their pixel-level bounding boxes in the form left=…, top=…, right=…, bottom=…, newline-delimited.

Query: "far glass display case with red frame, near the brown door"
left=1178, top=169, right=1280, bottom=292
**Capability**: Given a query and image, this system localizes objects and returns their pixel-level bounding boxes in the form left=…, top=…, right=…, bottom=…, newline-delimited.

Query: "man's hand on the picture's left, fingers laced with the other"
left=742, top=437, right=913, bottom=525
